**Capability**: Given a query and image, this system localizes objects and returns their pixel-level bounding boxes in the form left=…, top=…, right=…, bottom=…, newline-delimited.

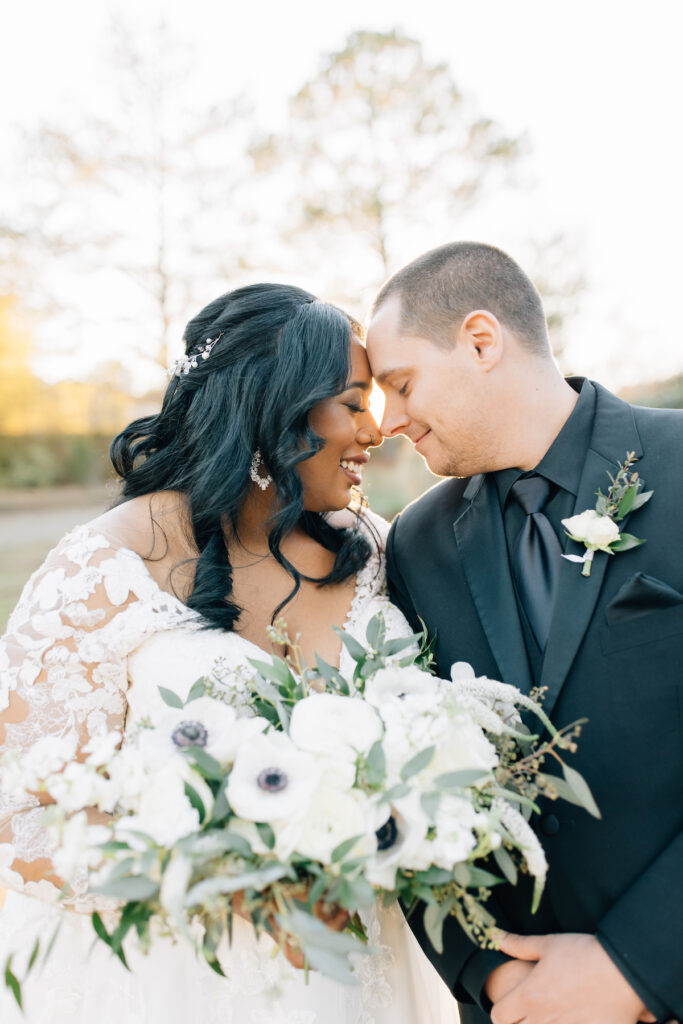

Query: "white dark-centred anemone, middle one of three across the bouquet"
left=226, top=732, right=321, bottom=821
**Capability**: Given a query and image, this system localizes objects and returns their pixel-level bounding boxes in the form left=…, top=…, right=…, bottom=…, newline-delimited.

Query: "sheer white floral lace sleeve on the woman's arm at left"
left=0, top=526, right=192, bottom=900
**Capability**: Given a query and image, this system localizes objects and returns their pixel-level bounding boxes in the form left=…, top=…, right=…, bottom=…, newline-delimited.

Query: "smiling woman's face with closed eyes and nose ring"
left=298, top=337, right=381, bottom=512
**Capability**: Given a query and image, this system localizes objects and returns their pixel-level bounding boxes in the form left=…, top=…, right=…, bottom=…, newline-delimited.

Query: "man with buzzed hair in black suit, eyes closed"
left=368, top=243, right=683, bottom=1024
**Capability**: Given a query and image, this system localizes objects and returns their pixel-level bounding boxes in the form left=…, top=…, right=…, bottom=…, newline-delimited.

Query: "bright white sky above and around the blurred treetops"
left=0, top=0, right=683, bottom=388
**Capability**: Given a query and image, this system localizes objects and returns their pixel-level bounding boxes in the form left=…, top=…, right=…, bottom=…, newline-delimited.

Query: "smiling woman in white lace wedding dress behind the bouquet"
left=0, top=285, right=458, bottom=1024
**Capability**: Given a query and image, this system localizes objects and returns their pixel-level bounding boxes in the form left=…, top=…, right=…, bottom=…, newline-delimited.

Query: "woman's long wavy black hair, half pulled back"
left=111, top=284, right=371, bottom=630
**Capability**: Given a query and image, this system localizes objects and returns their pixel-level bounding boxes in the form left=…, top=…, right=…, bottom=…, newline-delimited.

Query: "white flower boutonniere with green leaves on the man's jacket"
left=562, top=452, right=654, bottom=575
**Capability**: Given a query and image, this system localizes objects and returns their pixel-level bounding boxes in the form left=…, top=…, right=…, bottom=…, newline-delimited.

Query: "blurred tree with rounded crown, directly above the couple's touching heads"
left=252, top=31, right=524, bottom=303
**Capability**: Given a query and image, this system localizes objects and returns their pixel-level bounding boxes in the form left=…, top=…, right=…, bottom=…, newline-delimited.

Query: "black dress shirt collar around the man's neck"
left=494, top=377, right=595, bottom=507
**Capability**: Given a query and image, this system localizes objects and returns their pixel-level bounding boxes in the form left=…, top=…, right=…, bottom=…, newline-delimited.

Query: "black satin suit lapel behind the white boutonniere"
left=541, top=385, right=642, bottom=715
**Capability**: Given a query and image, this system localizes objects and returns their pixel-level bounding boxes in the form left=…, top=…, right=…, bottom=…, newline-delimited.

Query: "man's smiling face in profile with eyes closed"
left=367, top=296, right=497, bottom=476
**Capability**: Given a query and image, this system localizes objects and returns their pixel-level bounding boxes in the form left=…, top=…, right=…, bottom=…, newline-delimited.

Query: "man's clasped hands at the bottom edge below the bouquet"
left=486, top=933, right=655, bottom=1024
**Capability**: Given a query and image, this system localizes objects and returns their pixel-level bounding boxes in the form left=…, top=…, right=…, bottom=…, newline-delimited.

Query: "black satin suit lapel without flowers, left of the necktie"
left=454, top=476, right=531, bottom=692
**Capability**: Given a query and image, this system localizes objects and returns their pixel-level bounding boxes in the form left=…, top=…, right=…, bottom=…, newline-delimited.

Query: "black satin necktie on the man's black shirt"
left=510, top=474, right=562, bottom=651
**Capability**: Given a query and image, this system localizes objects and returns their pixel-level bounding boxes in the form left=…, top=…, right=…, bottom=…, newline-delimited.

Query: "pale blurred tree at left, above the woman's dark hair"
left=0, top=20, right=251, bottom=367
